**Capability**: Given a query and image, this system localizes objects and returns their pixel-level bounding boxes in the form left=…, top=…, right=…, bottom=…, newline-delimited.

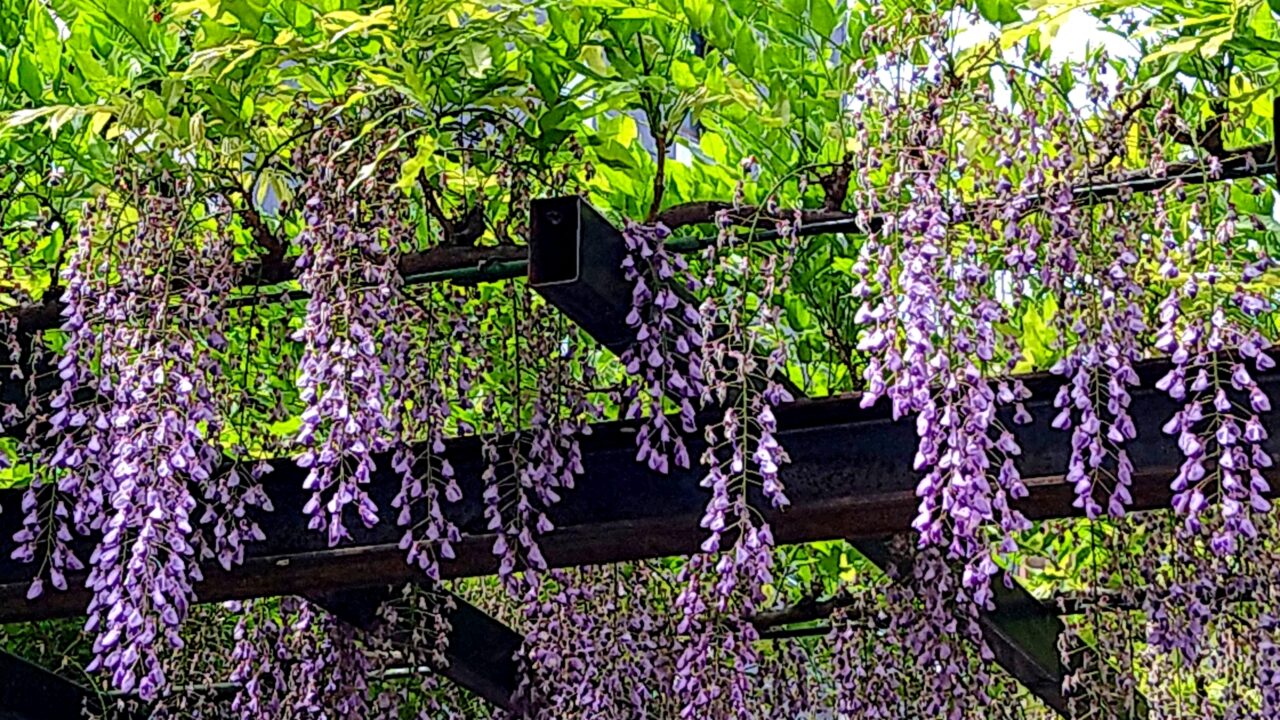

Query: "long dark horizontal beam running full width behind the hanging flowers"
left=0, top=351, right=1280, bottom=623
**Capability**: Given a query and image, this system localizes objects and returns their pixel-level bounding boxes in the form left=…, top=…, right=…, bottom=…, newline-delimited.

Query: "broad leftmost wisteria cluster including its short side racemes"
left=14, top=178, right=245, bottom=700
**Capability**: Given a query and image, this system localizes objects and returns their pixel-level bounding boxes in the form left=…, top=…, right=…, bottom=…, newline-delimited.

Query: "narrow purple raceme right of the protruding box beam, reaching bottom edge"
left=673, top=199, right=800, bottom=717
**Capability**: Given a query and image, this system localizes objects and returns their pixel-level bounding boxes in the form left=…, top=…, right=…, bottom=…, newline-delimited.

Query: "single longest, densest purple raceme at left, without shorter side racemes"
left=69, top=183, right=229, bottom=700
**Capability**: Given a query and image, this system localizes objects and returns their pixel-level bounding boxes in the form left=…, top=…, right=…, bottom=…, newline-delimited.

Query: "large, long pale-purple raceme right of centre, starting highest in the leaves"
left=854, top=44, right=1036, bottom=605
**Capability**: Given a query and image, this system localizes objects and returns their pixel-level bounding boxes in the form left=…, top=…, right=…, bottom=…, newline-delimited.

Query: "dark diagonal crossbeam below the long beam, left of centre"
left=307, top=587, right=524, bottom=714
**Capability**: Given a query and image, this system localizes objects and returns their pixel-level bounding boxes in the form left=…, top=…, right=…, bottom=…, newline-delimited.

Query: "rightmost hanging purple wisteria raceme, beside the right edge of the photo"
left=1140, top=172, right=1275, bottom=691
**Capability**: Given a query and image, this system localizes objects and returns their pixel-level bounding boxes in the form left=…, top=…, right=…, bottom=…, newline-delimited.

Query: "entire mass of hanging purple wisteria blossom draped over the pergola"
left=0, top=6, right=1280, bottom=720
